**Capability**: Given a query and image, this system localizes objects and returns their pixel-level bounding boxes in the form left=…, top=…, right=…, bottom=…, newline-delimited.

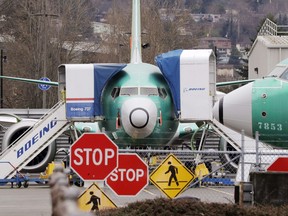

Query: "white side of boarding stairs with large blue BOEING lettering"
left=0, top=101, right=70, bottom=179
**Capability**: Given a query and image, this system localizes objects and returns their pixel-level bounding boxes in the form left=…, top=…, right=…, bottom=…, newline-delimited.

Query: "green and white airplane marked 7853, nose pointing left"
left=213, top=59, right=288, bottom=150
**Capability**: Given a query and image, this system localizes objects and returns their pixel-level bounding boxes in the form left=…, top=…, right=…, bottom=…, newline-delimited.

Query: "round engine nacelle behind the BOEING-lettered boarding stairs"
left=2, top=119, right=56, bottom=173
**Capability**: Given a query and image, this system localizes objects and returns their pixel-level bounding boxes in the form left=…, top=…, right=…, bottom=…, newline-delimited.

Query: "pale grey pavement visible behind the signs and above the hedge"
left=0, top=185, right=234, bottom=216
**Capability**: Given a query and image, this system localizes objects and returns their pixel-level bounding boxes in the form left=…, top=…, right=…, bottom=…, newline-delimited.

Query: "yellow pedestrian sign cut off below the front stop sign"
left=78, top=183, right=117, bottom=213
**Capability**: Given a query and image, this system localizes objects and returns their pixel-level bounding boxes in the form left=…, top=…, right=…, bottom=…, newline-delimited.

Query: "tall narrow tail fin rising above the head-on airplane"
left=130, top=0, right=142, bottom=64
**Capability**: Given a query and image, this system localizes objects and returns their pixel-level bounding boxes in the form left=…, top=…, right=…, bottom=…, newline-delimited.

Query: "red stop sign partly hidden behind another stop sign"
left=106, top=153, right=149, bottom=196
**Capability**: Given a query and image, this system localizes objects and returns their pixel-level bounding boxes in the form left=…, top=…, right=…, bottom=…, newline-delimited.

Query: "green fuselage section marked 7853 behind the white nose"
left=252, top=77, right=288, bottom=148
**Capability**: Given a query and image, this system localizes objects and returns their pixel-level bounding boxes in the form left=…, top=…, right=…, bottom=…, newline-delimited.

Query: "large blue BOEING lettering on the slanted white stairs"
left=17, top=119, right=57, bottom=158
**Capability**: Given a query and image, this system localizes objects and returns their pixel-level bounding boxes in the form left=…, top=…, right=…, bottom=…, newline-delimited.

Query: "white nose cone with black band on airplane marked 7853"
left=213, top=83, right=253, bottom=136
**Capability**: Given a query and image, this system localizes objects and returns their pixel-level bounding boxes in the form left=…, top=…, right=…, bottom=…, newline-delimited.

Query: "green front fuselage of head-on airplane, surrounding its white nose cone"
left=100, top=63, right=179, bottom=147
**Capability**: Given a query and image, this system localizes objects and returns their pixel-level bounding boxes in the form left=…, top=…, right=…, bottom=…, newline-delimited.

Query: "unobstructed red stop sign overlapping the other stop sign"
left=70, top=133, right=118, bottom=180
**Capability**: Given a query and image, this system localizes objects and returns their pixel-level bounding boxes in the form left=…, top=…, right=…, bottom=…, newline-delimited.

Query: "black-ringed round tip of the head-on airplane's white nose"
left=130, top=108, right=149, bottom=128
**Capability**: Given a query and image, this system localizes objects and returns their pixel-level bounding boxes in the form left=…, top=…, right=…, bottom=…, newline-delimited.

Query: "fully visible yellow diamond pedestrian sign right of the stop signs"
left=150, top=154, right=195, bottom=199
